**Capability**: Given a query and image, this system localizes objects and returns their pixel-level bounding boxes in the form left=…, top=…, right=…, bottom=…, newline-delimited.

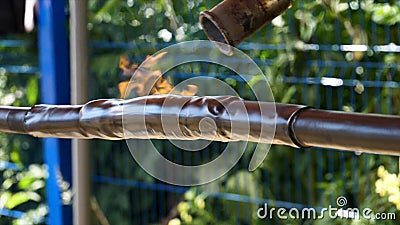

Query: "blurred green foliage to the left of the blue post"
left=0, top=35, right=44, bottom=225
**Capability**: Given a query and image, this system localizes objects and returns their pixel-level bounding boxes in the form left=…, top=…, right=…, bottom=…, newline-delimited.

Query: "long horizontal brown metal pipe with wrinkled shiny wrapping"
left=0, top=95, right=400, bottom=155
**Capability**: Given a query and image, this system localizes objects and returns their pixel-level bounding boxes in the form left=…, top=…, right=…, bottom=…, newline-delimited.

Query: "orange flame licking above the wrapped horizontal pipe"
left=118, top=52, right=198, bottom=98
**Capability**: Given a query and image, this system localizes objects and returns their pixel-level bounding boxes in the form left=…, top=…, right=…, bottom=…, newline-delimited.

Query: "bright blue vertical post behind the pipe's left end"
left=38, top=0, right=72, bottom=225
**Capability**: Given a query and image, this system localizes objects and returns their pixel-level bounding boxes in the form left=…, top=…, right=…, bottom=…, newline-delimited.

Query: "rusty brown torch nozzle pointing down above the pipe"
left=200, top=0, right=292, bottom=56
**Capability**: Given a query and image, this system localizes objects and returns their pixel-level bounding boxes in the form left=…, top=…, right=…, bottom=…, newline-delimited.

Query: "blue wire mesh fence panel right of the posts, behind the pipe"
left=88, top=0, right=400, bottom=224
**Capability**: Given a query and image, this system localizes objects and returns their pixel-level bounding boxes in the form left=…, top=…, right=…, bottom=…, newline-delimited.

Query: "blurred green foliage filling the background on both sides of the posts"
left=0, top=0, right=400, bottom=224
